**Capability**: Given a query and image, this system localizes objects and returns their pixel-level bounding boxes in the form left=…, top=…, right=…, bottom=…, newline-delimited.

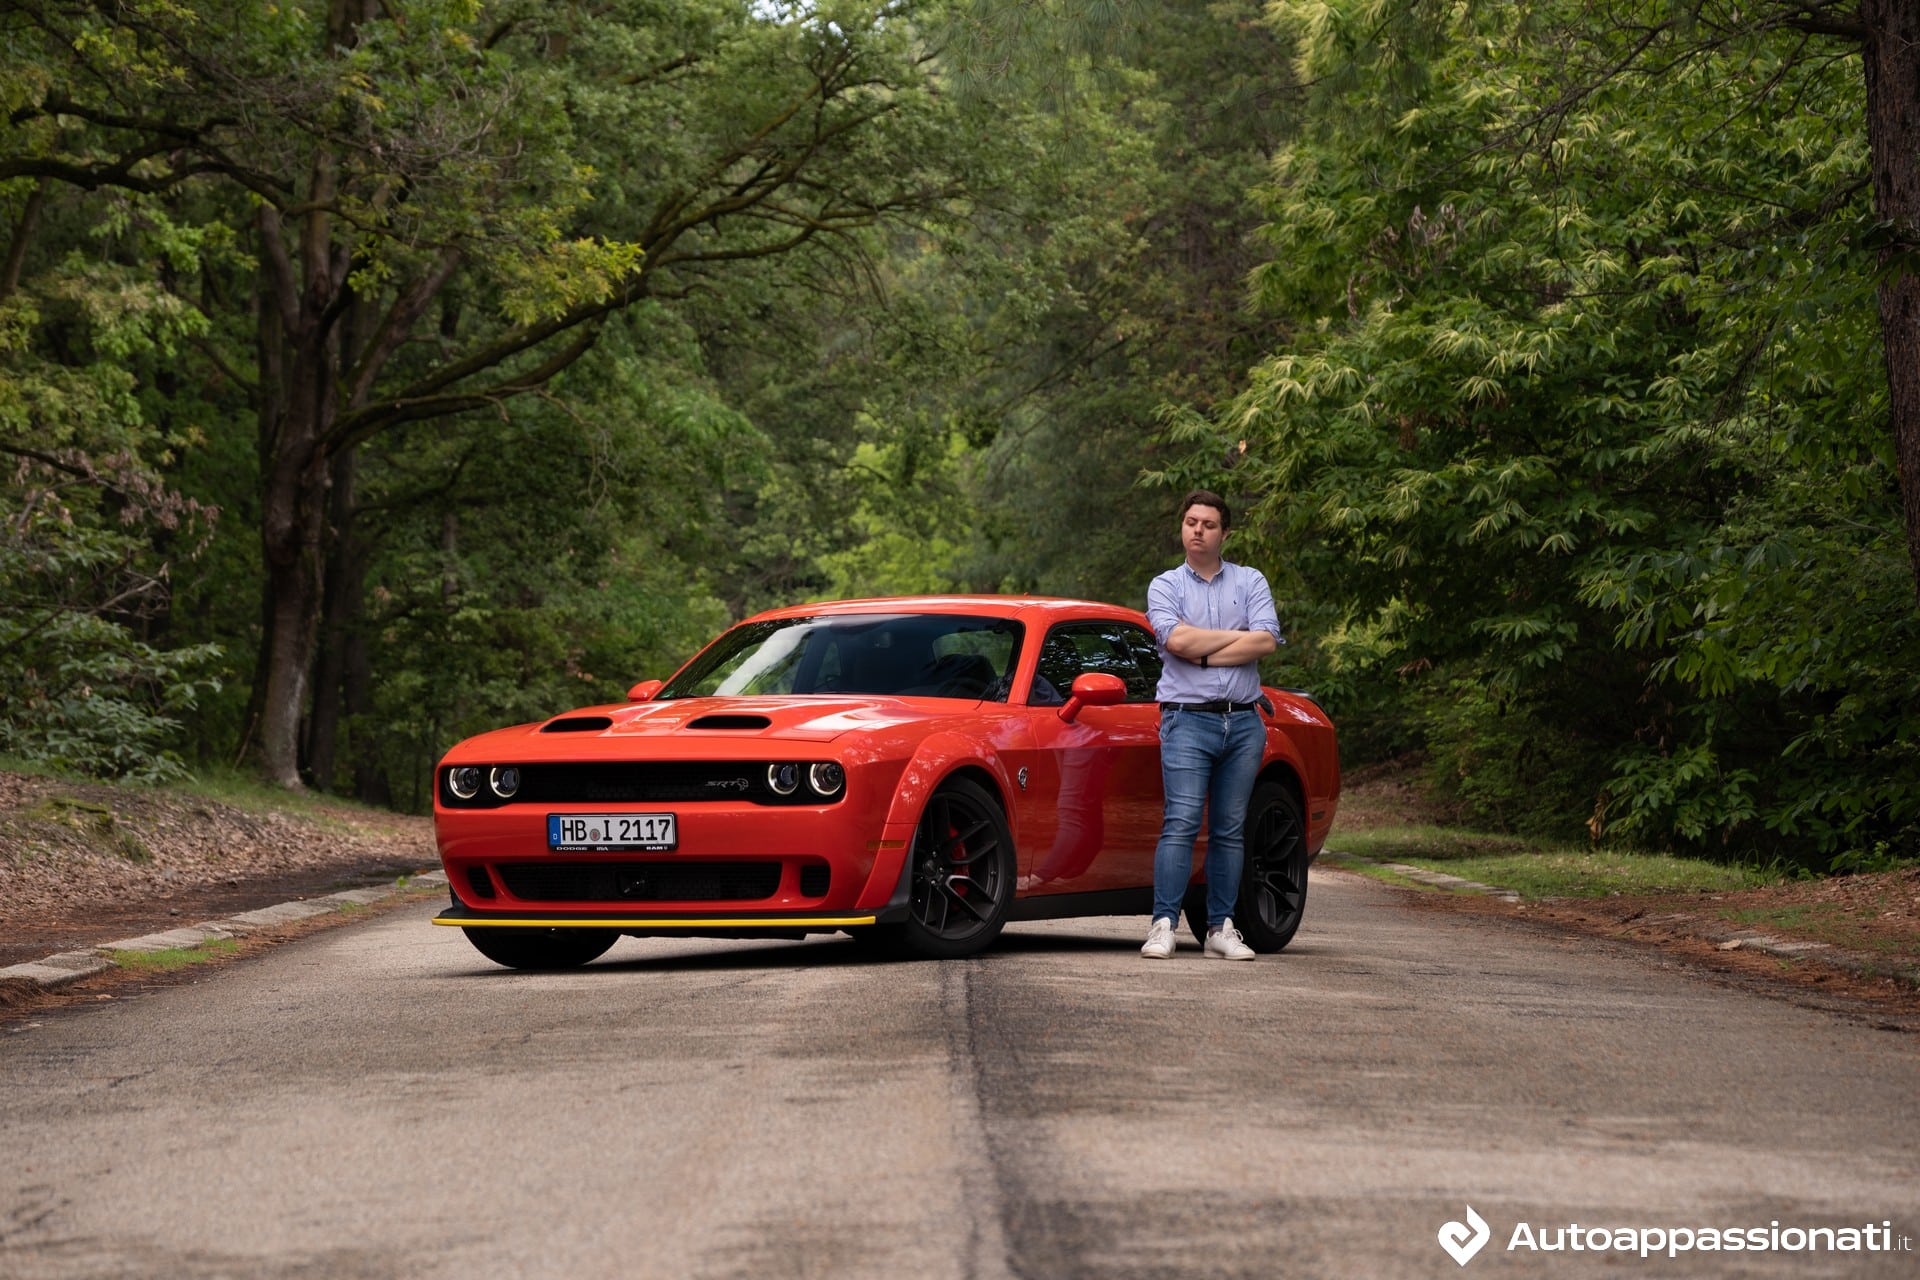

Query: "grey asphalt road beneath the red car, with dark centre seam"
left=0, top=871, right=1920, bottom=1280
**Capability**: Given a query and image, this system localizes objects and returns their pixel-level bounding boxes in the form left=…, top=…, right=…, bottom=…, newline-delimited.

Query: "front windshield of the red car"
left=655, top=614, right=1023, bottom=702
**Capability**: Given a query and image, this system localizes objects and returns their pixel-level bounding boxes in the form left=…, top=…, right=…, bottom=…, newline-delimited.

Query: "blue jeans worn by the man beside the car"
left=1154, top=708, right=1267, bottom=927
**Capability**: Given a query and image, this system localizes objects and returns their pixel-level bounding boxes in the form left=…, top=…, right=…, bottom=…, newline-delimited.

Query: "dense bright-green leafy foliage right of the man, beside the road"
left=1171, top=2, right=1920, bottom=864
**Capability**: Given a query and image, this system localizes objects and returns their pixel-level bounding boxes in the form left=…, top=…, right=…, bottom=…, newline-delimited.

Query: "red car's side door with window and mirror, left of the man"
left=1023, top=620, right=1162, bottom=892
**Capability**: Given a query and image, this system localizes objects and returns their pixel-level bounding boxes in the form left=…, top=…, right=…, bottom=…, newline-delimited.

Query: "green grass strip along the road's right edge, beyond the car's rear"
left=1331, top=827, right=1782, bottom=898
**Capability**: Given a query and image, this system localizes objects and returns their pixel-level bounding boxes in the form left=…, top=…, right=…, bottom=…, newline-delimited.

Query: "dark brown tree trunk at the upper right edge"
left=1860, top=0, right=1920, bottom=604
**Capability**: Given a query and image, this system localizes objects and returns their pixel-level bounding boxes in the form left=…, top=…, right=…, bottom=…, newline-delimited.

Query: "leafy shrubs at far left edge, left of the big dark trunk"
left=0, top=182, right=221, bottom=781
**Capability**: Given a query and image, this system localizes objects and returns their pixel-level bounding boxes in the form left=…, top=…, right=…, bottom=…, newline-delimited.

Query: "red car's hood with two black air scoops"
left=534, top=697, right=952, bottom=743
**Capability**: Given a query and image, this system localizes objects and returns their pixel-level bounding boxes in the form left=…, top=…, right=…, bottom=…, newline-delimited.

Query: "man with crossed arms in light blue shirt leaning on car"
left=1140, top=489, right=1281, bottom=960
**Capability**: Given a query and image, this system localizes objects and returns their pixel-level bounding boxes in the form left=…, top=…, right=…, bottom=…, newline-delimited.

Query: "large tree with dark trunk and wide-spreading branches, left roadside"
left=0, top=0, right=975, bottom=785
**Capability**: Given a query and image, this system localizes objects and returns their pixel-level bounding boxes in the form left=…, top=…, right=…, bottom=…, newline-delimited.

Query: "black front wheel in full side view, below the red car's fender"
left=875, top=777, right=1018, bottom=960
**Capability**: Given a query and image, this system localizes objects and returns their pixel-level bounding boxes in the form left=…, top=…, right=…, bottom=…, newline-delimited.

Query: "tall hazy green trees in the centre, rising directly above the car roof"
left=868, top=2, right=1298, bottom=603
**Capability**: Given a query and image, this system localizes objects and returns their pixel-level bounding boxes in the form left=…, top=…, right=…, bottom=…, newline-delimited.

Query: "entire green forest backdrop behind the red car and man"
left=0, top=0, right=1920, bottom=869
